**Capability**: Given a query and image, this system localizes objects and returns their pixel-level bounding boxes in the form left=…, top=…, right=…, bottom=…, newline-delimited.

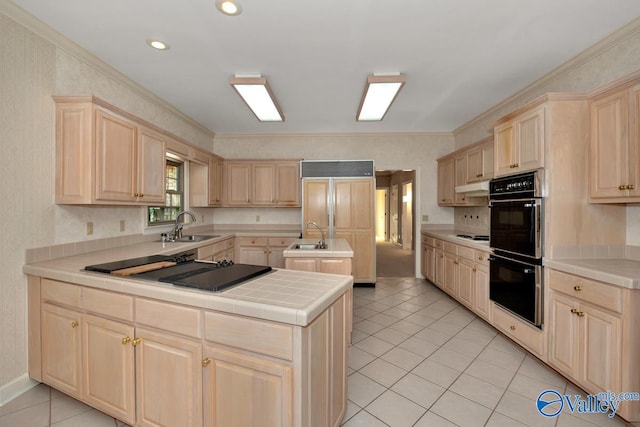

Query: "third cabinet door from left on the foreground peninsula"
left=135, top=328, right=202, bottom=427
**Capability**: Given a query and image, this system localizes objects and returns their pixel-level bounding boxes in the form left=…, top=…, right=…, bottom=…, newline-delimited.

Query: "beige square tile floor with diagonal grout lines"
left=0, top=277, right=624, bottom=427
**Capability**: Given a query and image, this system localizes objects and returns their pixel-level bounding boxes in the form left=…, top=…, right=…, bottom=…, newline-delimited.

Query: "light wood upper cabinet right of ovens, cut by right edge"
left=589, top=81, right=640, bottom=203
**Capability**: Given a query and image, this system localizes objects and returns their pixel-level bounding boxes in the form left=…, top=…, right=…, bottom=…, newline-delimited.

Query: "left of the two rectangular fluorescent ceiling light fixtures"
left=229, top=75, right=284, bottom=122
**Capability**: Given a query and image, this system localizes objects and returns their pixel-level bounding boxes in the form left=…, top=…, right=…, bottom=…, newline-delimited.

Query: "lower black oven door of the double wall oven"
left=489, top=255, right=542, bottom=327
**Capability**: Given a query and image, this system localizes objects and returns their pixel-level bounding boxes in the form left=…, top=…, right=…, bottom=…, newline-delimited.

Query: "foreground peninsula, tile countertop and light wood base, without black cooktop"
left=24, top=237, right=353, bottom=426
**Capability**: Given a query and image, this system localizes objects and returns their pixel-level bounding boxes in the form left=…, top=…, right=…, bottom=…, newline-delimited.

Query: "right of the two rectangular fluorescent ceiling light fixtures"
left=356, top=73, right=405, bottom=122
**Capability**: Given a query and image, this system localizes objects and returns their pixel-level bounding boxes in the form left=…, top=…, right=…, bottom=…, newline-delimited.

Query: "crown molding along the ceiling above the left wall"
left=0, top=0, right=215, bottom=137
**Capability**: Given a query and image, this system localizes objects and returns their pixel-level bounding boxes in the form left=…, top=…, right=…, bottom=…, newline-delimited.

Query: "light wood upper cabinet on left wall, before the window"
left=54, top=96, right=167, bottom=205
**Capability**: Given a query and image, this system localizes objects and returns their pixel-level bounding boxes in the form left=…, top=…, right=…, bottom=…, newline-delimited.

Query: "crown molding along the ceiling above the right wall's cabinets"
left=452, top=18, right=640, bottom=135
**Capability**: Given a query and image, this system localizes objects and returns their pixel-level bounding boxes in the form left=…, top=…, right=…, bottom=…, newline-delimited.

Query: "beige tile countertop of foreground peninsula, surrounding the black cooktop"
left=23, top=233, right=353, bottom=326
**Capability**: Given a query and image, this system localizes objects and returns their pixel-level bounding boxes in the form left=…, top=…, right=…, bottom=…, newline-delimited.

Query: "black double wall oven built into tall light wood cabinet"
left=489, top=170, right=544, bottom=328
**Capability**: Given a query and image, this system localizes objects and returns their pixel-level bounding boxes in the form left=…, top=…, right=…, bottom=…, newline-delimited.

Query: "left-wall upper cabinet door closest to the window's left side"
left=135, top=128, right=166, bottom=204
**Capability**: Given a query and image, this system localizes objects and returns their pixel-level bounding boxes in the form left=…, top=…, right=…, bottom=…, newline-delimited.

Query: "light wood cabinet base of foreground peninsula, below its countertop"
left=28, top=277, right=351, bottom=427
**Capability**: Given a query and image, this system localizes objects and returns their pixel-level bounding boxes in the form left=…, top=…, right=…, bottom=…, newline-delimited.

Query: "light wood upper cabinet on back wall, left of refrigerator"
left=224, top=160, right=300, bottom=207
